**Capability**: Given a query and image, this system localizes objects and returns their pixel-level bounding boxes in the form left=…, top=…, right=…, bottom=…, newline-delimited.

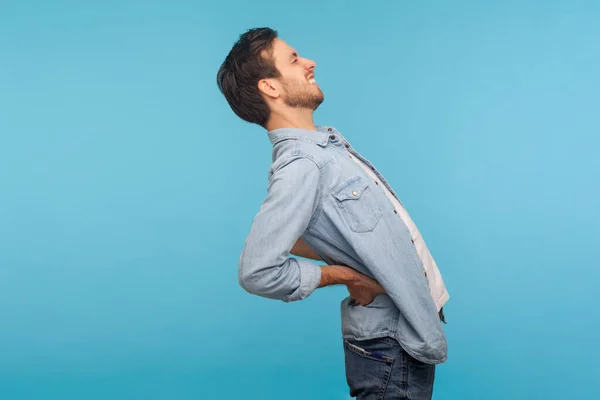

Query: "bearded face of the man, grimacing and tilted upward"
left=273, top=39, right=324, bottom=110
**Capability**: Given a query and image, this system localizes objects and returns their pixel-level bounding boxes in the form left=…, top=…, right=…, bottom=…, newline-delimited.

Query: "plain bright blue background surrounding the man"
left=0, top=0, right=600, bottom=400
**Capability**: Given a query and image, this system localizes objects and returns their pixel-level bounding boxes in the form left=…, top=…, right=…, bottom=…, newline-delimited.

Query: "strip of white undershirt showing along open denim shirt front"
left=350, top=155, right=450, bottom=311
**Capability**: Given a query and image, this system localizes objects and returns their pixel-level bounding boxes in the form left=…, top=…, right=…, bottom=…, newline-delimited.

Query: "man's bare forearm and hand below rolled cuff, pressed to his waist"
left=319, top=265, right=385, bottom=306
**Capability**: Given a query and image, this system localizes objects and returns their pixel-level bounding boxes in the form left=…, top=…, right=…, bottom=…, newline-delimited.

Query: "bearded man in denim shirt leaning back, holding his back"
left=217, top=28, right=449, bottom=400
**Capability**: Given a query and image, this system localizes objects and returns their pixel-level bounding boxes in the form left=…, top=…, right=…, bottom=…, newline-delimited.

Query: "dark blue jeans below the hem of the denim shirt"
left=344, top=337, right=435, bottom=400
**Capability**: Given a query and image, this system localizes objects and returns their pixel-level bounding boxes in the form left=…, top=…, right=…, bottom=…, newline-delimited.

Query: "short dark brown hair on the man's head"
left=217, top=28, right=280, bottom=127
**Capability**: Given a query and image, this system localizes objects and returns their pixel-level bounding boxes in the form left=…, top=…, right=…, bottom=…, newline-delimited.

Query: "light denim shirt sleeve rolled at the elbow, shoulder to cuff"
left=238, top=158, right=321, bottom=302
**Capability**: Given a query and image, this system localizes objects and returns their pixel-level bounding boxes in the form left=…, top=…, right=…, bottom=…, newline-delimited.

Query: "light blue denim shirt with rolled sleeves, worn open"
left=239, top=126, right=447, bottom=364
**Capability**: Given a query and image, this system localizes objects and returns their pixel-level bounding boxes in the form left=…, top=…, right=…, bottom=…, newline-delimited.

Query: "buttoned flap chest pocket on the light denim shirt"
left=331, top=176, right=382, bottom=233
